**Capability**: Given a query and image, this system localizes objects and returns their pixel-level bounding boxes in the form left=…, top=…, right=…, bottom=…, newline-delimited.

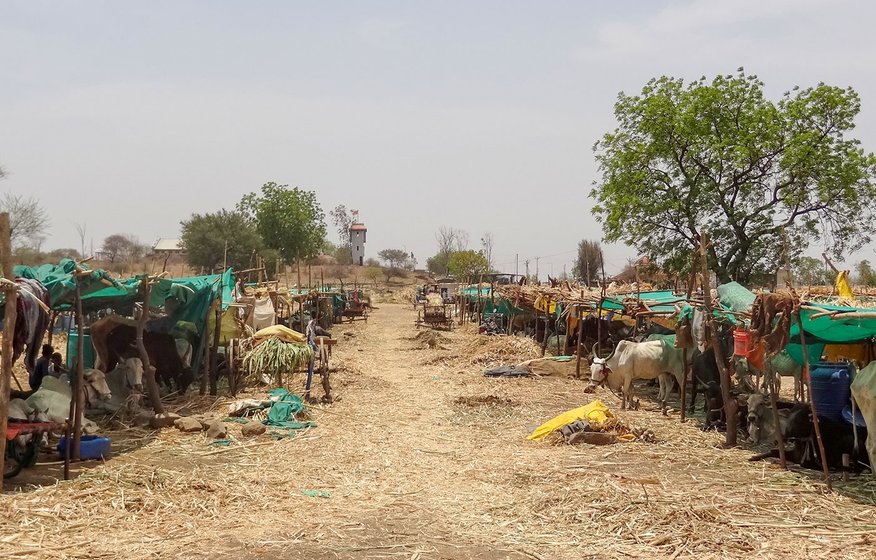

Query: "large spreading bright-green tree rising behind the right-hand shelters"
left=591, top=68, right=876, bottom=282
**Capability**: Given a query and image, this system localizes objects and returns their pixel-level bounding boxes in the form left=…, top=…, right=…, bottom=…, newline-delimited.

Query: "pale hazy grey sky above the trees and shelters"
left=0, top=0, right=876, bottom=276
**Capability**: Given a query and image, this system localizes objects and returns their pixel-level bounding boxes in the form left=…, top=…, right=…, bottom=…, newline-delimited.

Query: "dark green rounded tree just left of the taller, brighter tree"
left=180, top=209, right=260, bottom=270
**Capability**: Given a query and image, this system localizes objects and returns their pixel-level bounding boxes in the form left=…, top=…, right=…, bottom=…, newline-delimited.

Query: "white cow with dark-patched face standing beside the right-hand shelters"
left=588, top=340, right=683, bottom=409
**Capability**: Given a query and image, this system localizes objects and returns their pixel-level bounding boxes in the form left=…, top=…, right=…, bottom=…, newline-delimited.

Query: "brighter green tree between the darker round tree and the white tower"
left=238, top=183, right=326, bottom=263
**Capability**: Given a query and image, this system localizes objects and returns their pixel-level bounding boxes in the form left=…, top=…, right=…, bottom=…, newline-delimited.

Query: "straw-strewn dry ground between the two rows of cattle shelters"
left=0, top=304, right=876, bottom=560
